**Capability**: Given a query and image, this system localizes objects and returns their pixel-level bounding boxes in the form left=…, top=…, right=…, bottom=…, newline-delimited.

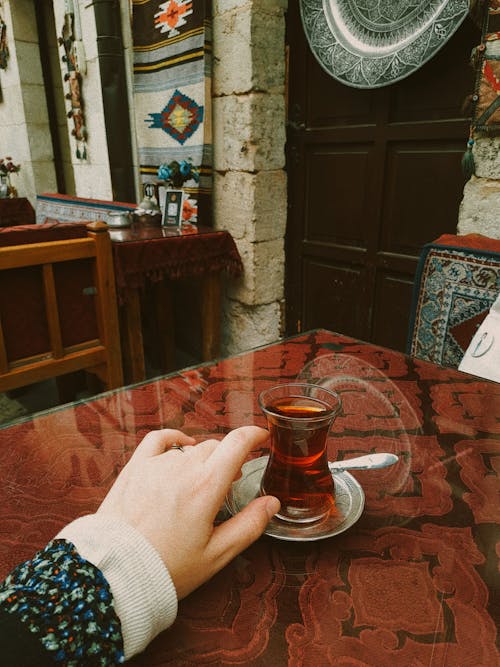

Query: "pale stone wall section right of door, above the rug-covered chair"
left=458, top=137, right=500, bottom=239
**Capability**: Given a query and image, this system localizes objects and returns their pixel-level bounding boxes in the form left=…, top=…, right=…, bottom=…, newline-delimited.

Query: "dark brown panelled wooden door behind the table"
left=286, top=2, right=479, bottom=350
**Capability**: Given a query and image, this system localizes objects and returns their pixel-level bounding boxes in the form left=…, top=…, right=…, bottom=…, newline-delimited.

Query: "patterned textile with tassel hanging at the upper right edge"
left=462, top=0, right=500, bottom=178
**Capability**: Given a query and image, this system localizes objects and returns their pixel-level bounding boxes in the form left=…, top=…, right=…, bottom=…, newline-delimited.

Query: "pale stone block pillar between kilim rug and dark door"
left=213, top=0, right=287, bottom=354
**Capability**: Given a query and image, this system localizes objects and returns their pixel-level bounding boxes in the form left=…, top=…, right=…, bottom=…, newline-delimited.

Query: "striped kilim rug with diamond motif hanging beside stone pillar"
left=132, top=0, right=212, bottom=224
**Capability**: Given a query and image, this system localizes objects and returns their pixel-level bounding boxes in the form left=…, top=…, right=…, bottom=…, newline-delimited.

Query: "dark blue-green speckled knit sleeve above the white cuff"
left=0, top=539, right=124, bottom=667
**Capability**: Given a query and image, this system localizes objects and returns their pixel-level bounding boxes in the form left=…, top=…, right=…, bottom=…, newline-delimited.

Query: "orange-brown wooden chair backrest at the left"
left=0, top=222, right=123, bottom=391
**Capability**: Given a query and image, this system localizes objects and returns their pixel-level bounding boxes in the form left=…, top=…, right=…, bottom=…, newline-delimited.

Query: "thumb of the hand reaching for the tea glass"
left=211, top=496, right=280, bottom=569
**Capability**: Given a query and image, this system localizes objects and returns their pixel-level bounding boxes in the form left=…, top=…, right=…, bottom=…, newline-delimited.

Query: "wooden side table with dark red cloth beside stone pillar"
left=111, top=227, right=243, bottom=383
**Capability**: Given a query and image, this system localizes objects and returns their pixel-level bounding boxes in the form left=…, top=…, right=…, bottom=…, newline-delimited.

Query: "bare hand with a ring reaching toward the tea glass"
left=98, top=426, right=279, bottom=599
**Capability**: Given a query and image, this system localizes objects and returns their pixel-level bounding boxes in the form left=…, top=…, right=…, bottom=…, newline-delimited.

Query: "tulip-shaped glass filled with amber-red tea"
left=259, top=383, right=341, bottom=524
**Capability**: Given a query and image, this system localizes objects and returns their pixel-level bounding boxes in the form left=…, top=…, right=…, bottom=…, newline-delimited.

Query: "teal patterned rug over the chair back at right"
left=407, top=234, right=500, bottom=368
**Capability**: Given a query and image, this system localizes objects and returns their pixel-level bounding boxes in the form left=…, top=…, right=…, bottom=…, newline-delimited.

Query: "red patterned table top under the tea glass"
left=0, top=330, right=500, bottom=667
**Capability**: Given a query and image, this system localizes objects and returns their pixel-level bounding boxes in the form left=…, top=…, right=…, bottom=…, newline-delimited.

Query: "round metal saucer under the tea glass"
left=226, top=456, right=365, bottom=542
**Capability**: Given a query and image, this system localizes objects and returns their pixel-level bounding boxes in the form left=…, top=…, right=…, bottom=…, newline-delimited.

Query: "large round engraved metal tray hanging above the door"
left=300, top=0, right=469, bottom=88
